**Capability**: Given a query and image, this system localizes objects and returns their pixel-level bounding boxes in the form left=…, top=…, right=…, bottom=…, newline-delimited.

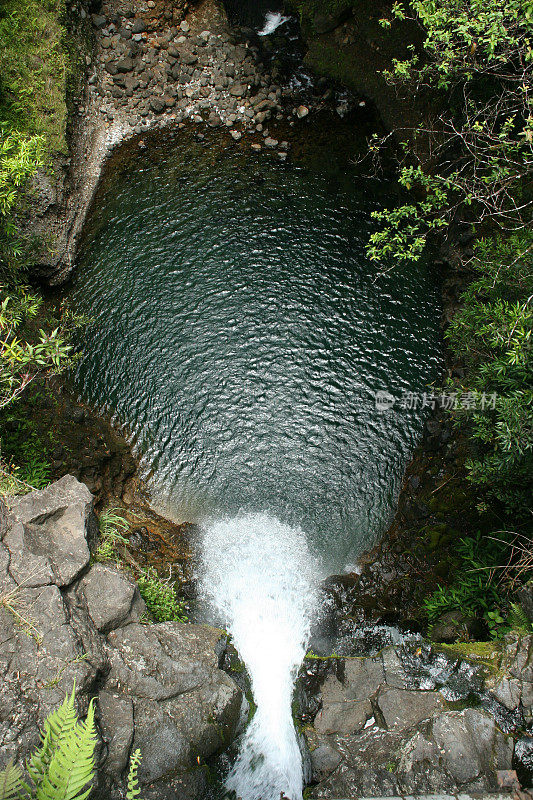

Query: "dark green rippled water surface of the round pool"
left=72, top=126, right=438, bottom=572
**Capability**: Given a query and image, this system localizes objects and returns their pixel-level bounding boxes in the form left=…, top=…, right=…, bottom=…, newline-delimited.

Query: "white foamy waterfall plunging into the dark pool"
left=197, top=513, right=320, bottom=800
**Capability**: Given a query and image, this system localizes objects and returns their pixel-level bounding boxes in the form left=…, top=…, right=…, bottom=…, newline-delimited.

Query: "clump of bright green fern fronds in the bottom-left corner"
left=0, top=689, right=96, bottom=800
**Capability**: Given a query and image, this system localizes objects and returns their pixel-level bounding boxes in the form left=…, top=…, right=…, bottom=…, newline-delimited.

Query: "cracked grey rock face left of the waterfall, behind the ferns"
left=0, top=475, right=242, bottom=800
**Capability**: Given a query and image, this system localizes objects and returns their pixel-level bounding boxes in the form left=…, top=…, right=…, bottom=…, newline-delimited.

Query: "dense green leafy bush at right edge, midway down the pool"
left=446, top=234, right=533, bottom=517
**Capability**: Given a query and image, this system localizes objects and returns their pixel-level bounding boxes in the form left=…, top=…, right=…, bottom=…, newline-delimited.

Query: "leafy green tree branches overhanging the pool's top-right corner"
left=368, top=0, right=533, bottom=262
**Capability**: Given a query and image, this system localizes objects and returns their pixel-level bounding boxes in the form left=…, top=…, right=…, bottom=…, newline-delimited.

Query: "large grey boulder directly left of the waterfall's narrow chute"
left=105, top=622, right=242, bottom=784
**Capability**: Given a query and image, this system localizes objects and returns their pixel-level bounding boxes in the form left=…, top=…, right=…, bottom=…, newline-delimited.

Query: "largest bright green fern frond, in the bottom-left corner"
left=35, top=701, right=96, bottom=800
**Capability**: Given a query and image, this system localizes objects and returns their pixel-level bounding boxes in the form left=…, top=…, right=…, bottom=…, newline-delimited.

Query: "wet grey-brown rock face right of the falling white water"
left=304, top=636, right=533, bottom=800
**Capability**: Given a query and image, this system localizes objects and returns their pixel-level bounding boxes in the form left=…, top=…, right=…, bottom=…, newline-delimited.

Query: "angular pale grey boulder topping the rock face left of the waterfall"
left=6, top=475, right=93, bottom=587
